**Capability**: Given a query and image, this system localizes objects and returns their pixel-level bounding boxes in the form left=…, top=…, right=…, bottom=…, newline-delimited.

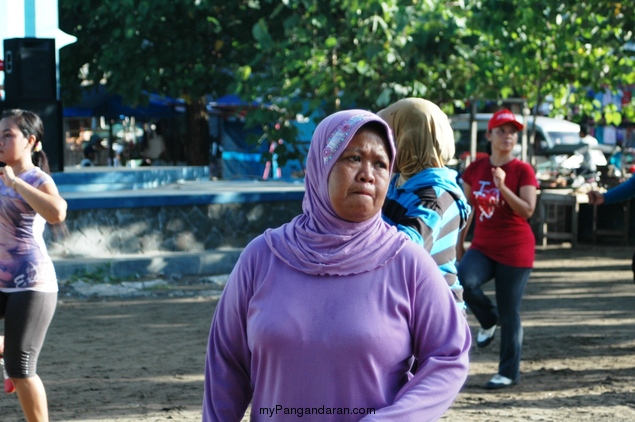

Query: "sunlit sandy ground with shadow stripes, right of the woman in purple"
left=444, top=247, right=635, bottom=421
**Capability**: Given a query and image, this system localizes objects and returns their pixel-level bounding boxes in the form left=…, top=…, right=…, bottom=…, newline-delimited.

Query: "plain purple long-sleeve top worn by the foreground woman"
left=203, top=236, right=471, bottom=422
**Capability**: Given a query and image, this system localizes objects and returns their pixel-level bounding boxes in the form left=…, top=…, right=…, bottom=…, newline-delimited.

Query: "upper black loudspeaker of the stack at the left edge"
left=4, top=38, right=57, bottom=101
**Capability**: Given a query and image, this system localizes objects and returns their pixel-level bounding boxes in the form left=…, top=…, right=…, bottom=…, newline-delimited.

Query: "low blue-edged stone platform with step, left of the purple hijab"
left=45, top=168, right=304, bottom=280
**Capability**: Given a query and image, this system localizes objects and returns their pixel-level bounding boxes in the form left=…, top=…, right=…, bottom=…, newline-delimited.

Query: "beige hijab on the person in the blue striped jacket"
left=377, top=98, right=454, bottom=186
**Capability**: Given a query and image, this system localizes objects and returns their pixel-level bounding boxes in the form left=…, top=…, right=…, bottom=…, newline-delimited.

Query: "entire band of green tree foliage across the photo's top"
left=59, top=0, right=635, bottom=164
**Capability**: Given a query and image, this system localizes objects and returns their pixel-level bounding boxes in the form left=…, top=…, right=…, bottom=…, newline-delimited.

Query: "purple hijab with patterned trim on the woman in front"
left=264, top=110, right=407, bottom=275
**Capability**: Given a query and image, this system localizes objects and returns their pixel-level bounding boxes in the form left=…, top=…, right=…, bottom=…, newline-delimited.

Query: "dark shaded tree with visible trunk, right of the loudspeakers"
left=59, top=0, right=264, bottom=165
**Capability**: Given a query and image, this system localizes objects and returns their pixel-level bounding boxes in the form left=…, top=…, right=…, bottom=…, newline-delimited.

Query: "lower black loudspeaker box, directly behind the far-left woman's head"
left=0, top=99, right=65, bottom=173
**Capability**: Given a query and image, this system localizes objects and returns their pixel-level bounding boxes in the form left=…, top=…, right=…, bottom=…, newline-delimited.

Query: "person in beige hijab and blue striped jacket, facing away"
left=378, top=98, right=470, bottom=312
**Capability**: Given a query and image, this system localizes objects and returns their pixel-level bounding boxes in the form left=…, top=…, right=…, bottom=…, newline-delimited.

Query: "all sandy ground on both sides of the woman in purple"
left=0, top=246, right=635, bottom=422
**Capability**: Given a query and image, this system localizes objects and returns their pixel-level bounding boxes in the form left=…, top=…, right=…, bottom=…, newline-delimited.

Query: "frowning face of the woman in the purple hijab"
left=328, top=128, right=390, bottom=223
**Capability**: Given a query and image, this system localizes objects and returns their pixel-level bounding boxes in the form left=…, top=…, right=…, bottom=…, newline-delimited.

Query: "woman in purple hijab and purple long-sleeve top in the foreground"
left=203, top=110, right=471, bottom=422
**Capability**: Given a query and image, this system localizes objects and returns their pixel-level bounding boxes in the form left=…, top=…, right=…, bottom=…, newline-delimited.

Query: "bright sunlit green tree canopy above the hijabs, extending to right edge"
left=231, top=0, right=635, bottom=162
